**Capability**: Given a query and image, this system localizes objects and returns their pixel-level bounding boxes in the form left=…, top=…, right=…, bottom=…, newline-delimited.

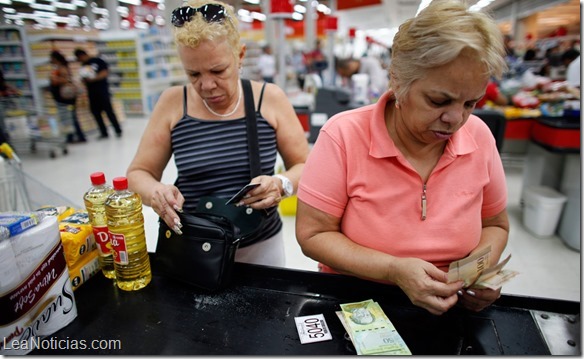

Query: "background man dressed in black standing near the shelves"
left=75, top=49, right=122, bottom=139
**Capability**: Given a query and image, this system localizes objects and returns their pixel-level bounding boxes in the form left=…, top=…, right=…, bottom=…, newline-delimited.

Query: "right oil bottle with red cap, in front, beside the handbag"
left=105, top=177, right=152, bottom=291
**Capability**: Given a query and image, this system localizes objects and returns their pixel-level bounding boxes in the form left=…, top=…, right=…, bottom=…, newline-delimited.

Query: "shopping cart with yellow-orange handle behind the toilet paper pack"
left=0, top=143, right=83, bottom=212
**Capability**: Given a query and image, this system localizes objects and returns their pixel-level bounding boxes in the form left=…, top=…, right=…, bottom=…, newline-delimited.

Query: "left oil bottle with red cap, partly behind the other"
left=83, top=172, right=116, bottom=279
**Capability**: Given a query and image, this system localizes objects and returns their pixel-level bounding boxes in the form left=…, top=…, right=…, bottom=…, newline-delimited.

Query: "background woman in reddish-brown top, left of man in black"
left=49, top=50, right=87, bottom=143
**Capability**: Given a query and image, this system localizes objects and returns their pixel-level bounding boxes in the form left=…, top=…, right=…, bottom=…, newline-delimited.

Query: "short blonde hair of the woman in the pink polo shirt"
left=390, top=0, right=506, bottom=98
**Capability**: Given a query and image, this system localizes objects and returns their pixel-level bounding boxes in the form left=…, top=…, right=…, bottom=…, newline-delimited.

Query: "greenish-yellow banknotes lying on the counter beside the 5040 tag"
left=336, top=299, right=412, bottom=355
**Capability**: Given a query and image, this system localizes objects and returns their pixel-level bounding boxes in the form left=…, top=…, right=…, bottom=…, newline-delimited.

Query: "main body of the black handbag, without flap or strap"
left=156, top=213, right=241, bottom=291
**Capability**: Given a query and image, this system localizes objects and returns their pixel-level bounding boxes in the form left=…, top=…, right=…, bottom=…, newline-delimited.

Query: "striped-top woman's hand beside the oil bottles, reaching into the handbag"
left=150, top=183, right=185, bottom=234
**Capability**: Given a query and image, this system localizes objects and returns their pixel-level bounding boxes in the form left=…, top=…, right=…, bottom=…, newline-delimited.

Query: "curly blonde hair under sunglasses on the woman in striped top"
left=170, top=0, right=241, bottom=58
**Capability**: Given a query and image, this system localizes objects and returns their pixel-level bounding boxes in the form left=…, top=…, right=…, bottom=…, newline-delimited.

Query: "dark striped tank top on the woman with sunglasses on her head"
left=171, top=81, right=282, bottom=247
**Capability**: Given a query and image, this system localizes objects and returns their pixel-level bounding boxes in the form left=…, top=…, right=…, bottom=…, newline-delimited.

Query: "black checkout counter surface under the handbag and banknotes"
left=31, top=260, right=581, bottom=355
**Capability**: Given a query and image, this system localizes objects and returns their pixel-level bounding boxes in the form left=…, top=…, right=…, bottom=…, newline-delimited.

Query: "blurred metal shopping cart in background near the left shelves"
left=1, top=97, right=68, bottom=158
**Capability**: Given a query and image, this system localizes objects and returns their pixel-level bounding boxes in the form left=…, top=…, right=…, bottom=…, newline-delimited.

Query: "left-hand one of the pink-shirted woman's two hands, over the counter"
left=392, top=258, right=464, bottom=315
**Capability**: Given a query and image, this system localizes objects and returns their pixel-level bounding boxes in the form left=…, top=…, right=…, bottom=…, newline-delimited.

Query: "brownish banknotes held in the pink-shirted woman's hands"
left=448, top=246, right=519, bottom=290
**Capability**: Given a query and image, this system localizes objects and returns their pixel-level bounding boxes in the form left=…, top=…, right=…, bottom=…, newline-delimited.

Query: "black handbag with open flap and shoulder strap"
left=156, top=80, right=265, bottom=291
